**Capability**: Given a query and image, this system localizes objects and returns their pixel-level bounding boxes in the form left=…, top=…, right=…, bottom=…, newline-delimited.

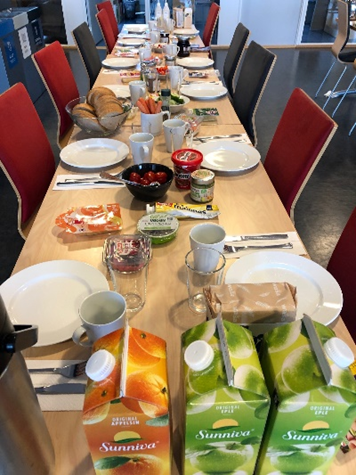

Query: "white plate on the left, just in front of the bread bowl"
left=59, top=139, right=129, bottom=168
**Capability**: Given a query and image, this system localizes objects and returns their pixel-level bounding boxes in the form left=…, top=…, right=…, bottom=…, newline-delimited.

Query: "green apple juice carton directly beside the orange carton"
left=182, top=315, right=270, bottom=475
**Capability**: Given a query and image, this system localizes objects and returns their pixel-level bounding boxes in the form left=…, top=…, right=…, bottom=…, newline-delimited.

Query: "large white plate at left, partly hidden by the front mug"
left=0, top=260, right=109, bottom=346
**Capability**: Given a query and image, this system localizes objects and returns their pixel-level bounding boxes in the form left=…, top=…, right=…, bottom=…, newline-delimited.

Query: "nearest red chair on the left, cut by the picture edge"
left=0, top=83, right=55, bottom=239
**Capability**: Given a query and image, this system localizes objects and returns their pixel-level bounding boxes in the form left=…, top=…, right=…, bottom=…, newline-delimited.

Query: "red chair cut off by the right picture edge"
left=327, top=208, right=356, bottom=339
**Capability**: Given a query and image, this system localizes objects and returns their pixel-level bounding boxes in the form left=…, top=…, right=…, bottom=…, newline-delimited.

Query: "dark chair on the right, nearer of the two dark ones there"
left=232, top=41, right=276, bottom=146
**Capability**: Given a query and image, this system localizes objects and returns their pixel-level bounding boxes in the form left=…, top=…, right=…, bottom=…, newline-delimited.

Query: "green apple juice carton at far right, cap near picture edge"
left=256, top=316, right=356, bottom=475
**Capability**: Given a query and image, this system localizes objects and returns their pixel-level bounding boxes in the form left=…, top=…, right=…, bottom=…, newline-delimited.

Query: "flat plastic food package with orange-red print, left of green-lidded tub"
left=56, top=203, right=122, bottom=234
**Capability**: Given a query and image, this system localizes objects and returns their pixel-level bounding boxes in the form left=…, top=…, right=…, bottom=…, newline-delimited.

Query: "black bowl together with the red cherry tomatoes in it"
left=119, top=163, right=174, bottom=203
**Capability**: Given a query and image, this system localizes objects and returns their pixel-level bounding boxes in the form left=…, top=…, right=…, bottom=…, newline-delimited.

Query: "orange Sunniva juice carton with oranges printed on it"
left=83, top=324, right=171, bottom=475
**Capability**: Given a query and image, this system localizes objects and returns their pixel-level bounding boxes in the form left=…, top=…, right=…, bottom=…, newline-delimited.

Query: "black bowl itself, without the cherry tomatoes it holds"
left=119, top=163, right=174, bottom=203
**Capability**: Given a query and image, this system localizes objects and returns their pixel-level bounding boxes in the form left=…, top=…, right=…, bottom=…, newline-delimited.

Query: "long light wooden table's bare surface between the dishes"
left=13, top=35, right=356, bottom=475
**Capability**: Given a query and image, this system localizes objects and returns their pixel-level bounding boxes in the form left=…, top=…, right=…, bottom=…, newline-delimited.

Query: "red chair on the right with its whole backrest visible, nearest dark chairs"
left=264, top=88, right=337, bottom=221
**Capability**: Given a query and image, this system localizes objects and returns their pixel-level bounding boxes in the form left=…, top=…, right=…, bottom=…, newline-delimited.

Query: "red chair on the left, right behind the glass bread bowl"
left=32, top=41, right=79, bottom=148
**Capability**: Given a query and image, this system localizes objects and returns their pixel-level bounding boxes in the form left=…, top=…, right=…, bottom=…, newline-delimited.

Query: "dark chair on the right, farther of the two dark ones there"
left=223, top=23, right=250, bottom=97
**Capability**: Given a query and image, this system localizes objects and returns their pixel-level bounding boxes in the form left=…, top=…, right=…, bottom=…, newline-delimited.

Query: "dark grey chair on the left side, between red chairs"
left=72, top=22, right=101, bottom=88
